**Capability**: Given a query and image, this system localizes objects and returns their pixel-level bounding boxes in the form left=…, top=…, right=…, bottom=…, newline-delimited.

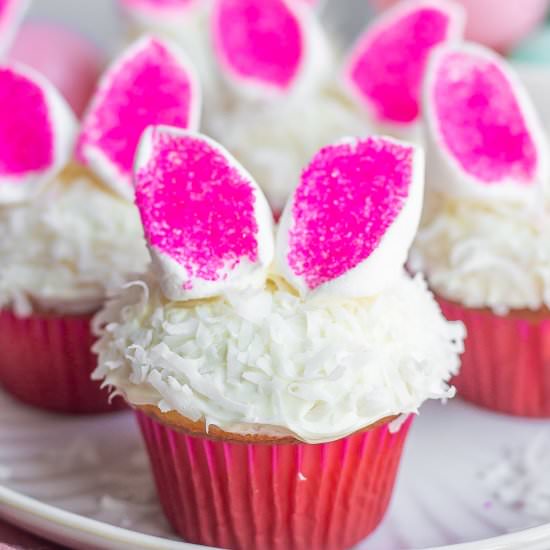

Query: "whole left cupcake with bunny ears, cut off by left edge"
left=0, top=38, right=202, bottom=413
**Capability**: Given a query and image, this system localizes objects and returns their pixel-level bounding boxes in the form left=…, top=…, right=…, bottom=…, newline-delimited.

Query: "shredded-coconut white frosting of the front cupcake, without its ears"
left=94, top=274, right=464, bottom=443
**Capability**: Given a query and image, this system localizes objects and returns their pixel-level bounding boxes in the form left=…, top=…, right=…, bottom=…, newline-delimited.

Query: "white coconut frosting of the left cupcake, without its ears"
left=0, top=174, right=149, bottom=315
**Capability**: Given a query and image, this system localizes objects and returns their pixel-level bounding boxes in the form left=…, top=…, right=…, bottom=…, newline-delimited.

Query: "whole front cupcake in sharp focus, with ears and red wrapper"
left=94, top=127, right=463, bottom=550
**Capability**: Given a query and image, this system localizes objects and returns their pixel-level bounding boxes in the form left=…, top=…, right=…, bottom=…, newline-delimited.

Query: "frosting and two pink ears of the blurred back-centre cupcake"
left=207, top=0, right=463, bottom=213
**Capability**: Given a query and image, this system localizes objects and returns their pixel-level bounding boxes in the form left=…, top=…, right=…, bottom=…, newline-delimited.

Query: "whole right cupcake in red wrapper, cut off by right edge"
left=410, top=44, right=550, bottom=417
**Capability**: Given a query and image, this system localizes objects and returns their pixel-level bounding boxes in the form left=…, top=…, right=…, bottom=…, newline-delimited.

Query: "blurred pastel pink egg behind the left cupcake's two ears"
left=8, top=22, right=105, bottom=117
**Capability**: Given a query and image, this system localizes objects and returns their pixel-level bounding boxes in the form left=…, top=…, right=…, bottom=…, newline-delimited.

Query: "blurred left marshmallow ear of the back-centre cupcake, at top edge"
left=211, top=0, right=328, bottom=98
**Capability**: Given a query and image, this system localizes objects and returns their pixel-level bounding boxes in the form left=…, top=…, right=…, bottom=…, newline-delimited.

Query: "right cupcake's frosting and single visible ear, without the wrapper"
left=410, top=44, right=550, bottom=314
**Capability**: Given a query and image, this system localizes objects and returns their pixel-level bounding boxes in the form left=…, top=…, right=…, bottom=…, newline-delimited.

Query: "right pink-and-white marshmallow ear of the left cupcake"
left=76, top=37, right=200, bottom=198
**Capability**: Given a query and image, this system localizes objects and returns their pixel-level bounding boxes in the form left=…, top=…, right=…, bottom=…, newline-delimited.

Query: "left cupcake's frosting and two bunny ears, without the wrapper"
left=0, top=38, right=203, bottom=315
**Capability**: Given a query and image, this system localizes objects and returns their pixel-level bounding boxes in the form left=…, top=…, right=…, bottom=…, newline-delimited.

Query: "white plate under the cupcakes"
left=0, top=392, right=550, bottom=550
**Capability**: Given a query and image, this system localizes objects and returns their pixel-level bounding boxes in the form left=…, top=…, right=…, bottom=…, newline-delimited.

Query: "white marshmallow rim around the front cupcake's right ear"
left=276, top=138, right=430, bottom=298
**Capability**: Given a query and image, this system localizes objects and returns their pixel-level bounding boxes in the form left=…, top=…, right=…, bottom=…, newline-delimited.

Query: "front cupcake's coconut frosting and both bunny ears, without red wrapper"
left=94, top=127, right=464, bottom=443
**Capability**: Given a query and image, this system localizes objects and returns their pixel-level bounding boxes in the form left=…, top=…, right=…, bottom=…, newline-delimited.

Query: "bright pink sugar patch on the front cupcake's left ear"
left=136, top=133, right=258, bottom=288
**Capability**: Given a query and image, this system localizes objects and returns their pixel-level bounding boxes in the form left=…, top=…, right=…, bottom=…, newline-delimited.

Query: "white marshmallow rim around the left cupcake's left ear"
left=0, top=64, right=78, bottom=204
